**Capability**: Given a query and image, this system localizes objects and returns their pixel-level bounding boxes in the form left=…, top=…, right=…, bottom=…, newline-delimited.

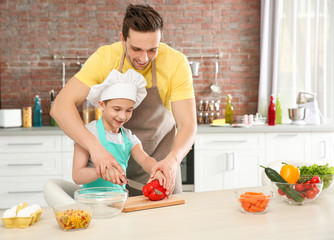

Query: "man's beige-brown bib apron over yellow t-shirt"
left=119, top=52, right=182, bottom=196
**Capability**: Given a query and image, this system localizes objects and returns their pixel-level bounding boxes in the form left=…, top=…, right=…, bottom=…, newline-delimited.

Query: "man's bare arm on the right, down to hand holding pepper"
left=151, top=98, right=197, bottom=195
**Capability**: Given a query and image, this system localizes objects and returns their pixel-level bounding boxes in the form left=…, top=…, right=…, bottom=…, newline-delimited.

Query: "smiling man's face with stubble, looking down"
left=121, top=29, right=161, bottom=70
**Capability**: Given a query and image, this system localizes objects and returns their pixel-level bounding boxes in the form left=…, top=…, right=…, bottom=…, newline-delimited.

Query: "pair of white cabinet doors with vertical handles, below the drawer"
left=195, top=151, right=264, bottom=192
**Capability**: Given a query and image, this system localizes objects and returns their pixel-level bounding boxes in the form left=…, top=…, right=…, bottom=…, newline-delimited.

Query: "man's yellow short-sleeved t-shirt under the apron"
left=75, top=42, right=194, bottom=110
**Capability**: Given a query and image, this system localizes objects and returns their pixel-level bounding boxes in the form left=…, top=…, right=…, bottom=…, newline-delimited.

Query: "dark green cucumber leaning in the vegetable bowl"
left=260, top=165, right=304, bottom=203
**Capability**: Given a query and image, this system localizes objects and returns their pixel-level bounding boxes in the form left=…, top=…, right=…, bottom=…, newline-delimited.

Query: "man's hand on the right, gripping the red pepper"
left=150, top=155, right=179, bottom=196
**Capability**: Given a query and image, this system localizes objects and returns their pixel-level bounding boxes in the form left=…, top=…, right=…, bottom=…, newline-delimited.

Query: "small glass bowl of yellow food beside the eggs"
left=52, top=204, right=93, bottom=231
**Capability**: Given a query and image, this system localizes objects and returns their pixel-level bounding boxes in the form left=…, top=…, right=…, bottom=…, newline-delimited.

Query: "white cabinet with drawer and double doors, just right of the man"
left=195, top=133, right=264, bottom=192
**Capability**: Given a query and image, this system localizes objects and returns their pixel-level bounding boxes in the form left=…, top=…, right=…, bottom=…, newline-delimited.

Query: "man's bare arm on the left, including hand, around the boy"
left=50, top=77, right=126, bottom=183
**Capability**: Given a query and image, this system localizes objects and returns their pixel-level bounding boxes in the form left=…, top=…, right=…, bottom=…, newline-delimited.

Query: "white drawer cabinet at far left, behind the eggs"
left=0, top=133, right=73, bottom=209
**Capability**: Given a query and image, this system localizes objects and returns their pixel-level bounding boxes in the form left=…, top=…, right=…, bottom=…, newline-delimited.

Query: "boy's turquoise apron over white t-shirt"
left=82, top=118, right=132, bottom=188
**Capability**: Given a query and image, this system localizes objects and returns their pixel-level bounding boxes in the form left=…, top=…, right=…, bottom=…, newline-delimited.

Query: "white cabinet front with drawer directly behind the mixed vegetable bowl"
left=266, top=132, right=311, bottom=163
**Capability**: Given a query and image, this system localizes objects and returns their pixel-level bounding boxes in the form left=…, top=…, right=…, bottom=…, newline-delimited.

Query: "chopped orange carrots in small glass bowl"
left=239, top=192, right=270, bottom=213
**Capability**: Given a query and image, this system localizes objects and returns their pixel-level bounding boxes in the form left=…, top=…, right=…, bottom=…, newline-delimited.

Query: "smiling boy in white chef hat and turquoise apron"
left=72, top=69, right=166, bottom=188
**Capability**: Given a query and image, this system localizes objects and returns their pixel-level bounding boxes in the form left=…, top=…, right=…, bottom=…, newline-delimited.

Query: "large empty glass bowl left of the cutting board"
left=74, top=186, right=128, bottom=218
